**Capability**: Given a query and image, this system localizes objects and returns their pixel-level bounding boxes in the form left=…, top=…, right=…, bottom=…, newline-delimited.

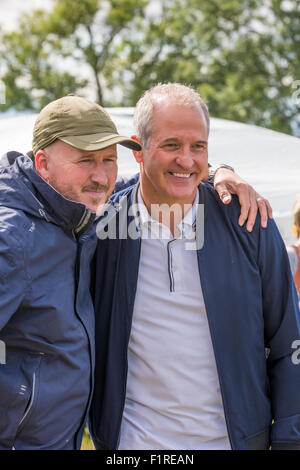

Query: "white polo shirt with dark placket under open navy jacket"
left=119, top=189, right=231, bottom=450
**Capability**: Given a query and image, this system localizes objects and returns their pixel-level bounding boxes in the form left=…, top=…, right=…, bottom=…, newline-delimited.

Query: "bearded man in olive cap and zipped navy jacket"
left=0, top=96, right=266, bottom=450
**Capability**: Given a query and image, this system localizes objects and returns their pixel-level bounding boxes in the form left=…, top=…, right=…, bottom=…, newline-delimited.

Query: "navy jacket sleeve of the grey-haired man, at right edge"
left=259, top=221, right=300, bottom=449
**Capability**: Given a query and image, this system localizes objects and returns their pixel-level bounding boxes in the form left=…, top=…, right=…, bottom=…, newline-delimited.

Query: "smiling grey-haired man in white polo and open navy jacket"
left=90, top=84, right=300, bottom=450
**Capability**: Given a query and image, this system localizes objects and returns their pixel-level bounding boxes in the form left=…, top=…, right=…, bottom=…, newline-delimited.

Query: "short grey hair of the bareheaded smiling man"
left=133, top=83, right=210, bottom=148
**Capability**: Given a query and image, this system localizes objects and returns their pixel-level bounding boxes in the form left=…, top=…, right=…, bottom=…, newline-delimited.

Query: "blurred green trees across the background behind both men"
left=0, top=0, right=300, bottom=136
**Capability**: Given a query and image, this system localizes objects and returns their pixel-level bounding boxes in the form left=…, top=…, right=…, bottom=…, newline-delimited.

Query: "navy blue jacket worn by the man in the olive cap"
left=0, top=152, right=96, bottom=450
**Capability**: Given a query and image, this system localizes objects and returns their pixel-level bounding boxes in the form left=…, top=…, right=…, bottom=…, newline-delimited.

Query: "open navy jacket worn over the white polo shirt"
left=90, top=183, right=300, bottom=449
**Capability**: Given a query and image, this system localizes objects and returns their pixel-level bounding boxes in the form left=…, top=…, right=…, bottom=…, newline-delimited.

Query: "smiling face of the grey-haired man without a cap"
left=137, top=101, right=208, bottom=209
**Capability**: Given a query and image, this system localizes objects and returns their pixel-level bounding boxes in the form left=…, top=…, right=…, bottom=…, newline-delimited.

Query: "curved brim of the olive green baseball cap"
left=58, top=133, right=142, bottom=151
